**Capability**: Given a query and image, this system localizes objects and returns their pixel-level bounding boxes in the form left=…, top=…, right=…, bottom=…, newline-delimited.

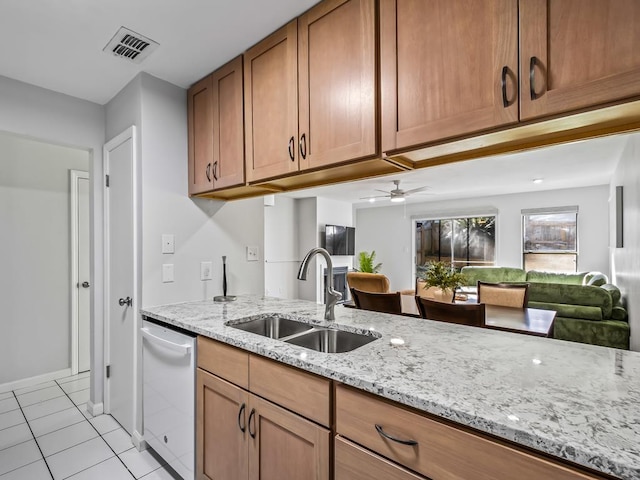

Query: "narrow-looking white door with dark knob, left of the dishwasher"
left=104, top=127, right=137, bottom=434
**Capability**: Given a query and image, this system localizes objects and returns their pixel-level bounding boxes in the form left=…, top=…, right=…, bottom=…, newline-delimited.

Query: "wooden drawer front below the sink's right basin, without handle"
left=249, top=355, right=331, bottom=426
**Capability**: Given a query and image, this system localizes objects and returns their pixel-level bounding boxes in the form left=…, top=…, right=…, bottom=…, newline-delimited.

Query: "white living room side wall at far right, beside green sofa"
left=609, top=133, right=640, bottom=351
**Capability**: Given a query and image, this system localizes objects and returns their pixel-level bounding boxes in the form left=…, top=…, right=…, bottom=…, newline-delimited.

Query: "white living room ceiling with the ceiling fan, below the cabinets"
left=282, top=135, right=628, bottom=208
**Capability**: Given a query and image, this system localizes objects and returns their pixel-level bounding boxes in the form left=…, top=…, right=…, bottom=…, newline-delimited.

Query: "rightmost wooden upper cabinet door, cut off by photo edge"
left=520, top=0, right=640, bottom=120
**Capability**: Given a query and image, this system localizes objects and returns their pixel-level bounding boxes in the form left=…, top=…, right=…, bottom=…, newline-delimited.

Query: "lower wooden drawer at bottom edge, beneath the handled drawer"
left=335, top=436, right=425, bottom=480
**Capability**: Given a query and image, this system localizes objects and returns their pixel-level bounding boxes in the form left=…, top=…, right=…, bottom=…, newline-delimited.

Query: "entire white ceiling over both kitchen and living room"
left=0, top=0, right=626, bottom=202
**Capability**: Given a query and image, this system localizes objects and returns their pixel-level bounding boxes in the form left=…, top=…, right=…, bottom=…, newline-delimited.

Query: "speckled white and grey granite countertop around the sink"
left=141, top=296, right=640, bottom=480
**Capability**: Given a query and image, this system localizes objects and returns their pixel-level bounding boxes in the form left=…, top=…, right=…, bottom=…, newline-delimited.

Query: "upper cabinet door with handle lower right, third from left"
left=244, top=20, right=298, bottom=182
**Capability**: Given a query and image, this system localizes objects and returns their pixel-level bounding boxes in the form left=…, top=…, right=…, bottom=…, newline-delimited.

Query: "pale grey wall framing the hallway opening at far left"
left=0, top=76, right=105, bottom=396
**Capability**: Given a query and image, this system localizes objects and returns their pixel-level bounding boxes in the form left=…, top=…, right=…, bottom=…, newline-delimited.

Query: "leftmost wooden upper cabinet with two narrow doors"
left=187, top=56, right=244, bottom=195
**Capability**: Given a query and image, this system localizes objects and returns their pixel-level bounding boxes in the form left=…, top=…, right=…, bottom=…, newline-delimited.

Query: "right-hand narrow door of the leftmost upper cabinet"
left=211, top=56, right=244, bottom=189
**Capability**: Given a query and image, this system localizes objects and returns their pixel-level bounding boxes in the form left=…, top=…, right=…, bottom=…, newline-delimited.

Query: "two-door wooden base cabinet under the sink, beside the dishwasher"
left=196, top=342, right=331, bottom=480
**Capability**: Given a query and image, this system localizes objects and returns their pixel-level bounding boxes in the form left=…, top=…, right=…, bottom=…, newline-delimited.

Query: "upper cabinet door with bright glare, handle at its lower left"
left=298, top=0, right=379, bottom=169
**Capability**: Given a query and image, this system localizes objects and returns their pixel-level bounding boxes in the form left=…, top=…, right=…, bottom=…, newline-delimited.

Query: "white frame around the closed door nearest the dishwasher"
left=102, top=125, right=142, bottom=438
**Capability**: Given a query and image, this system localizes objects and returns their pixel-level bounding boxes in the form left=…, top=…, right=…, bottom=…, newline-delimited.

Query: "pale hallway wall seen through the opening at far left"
left=0, top=132, right=89, bottom=384
